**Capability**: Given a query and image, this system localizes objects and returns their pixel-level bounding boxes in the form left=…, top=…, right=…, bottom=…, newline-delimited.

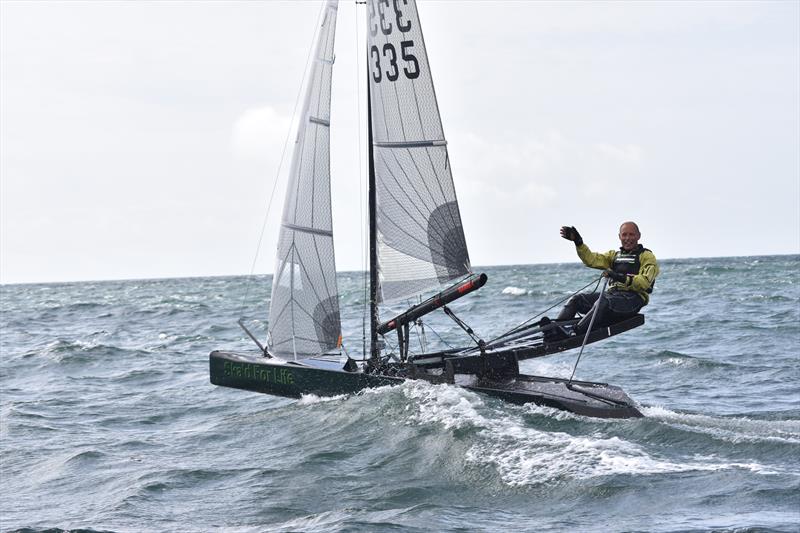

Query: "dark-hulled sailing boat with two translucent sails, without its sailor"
left=209, top=0, right=644, bottom=418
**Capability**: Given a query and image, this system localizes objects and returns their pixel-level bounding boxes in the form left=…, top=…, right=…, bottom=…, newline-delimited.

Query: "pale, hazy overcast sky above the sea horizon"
left=0, top=0, right=800, bottom=283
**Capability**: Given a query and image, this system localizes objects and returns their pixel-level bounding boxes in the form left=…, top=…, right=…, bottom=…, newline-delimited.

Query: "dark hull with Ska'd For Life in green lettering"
left=209, top=351, right=643, bottom=418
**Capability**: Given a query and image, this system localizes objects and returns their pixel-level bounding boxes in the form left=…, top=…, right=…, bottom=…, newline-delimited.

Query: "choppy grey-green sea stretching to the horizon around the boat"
left=0, top=255, right=800, bottom=532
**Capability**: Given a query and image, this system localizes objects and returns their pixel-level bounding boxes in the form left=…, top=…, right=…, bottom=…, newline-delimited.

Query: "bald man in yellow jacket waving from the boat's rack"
left=548, top=222, right=659, bottom=340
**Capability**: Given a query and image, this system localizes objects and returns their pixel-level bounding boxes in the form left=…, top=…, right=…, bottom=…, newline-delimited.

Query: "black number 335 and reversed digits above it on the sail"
left=369, top=0, right=419, bottom=83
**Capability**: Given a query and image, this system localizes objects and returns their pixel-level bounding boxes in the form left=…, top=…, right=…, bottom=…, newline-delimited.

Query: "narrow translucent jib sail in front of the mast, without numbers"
left=268, top=0, right=341, bottom=359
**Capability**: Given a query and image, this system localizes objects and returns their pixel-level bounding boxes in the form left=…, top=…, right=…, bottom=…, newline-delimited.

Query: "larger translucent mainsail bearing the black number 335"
left=367, top=0, right=471, bottom=300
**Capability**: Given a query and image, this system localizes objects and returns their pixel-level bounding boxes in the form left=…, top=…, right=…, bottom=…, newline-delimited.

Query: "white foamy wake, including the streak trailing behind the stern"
left=378, top=382, right=800, bottom=487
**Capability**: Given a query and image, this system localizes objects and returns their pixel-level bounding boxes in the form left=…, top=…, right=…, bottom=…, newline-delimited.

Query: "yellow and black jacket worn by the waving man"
left=577, top=244, right=658, bottom=305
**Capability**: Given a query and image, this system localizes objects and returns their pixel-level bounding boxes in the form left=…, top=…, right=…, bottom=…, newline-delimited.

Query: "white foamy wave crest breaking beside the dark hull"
left=382, top=383, right=788, bottom=487
